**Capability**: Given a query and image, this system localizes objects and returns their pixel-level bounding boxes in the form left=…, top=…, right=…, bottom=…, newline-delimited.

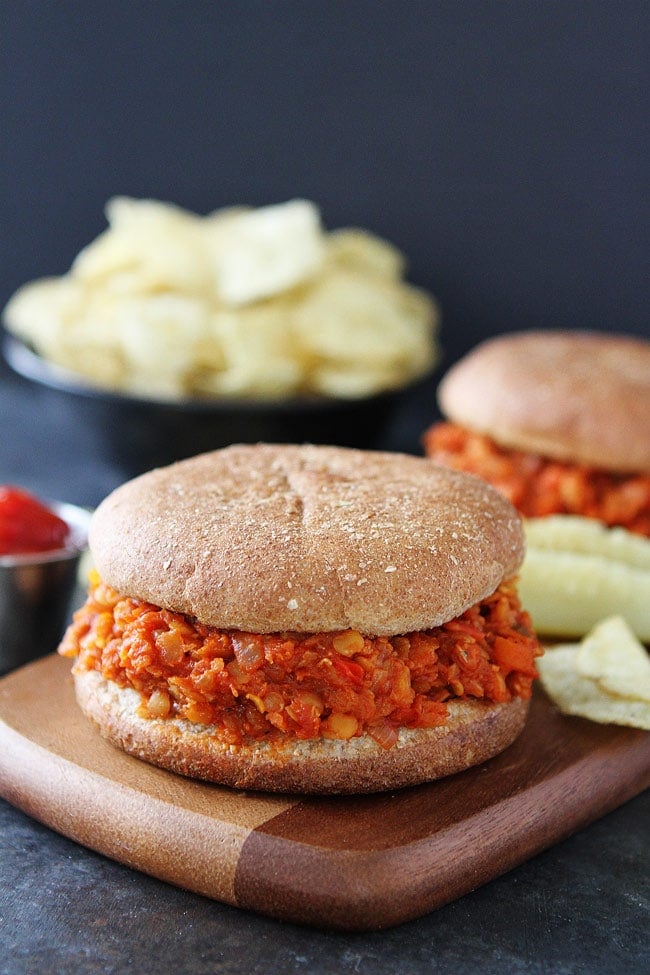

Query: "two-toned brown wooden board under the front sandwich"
left=0, top=656, right=650, bottom=930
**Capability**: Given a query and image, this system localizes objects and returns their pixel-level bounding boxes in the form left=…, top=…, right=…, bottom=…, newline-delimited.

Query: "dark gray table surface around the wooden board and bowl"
left=0, top=346, right=650, bottom=975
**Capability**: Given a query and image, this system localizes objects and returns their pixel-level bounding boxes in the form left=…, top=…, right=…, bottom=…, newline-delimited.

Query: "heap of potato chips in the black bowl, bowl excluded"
left=4, top=198, right=439, bottom=399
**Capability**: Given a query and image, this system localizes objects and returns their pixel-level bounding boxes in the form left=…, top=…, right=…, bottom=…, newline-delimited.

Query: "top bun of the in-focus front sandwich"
left=90, top=444, right=524, bottom=636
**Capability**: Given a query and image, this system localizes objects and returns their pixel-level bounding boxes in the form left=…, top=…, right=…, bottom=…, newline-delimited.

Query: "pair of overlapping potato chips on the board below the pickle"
left=537, top=616, right=650, bottom=731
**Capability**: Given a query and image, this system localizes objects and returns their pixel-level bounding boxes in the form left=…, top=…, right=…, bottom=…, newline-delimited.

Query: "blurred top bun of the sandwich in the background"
left=438, top=331, right=650, bottom=473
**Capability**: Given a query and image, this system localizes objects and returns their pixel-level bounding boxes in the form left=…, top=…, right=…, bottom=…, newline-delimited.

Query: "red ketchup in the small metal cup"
left=0, top=485, right=70, bottom=556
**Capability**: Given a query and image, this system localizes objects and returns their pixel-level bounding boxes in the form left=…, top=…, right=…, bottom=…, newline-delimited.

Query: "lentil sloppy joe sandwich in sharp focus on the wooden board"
left=60, top=444, right=541, bottom=793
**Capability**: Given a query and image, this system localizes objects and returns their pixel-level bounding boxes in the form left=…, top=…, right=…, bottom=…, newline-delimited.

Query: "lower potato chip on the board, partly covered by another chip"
left=537, top=644, right=650, bottom=731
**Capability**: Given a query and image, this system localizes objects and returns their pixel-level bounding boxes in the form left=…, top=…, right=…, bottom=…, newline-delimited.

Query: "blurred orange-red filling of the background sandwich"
left=423, top=423, right=650, bottom=537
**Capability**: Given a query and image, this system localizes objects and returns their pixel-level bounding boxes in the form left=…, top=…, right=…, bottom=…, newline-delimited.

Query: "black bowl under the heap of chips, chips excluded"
left=3, top=334, right=416, bottom=477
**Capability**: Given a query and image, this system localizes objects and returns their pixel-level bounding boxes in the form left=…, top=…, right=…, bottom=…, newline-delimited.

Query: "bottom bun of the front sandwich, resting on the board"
left=74, top=671, right=529, bottom=794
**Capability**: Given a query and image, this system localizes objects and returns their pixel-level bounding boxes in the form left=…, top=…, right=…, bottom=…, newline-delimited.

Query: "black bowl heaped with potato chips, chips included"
left=3, top=197, right=439, bottom=473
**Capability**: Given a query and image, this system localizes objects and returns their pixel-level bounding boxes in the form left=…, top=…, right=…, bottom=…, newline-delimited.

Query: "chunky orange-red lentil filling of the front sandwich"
left=59, top=573, right=541, bottom=748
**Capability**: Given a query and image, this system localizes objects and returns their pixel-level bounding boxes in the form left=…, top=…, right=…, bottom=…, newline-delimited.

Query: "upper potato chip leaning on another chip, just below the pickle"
left=576, top=616, right=650, bottom=703
